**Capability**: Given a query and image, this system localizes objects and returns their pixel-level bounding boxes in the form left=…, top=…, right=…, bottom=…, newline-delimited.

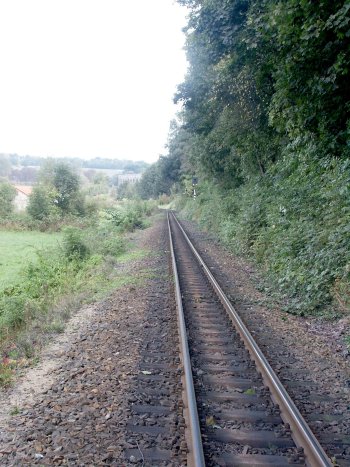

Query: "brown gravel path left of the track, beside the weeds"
left=0, top=214, right=181, bottom=467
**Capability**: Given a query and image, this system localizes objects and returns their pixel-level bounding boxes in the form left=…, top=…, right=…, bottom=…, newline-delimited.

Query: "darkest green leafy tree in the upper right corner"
left=257, top=0, right=350, bottom=157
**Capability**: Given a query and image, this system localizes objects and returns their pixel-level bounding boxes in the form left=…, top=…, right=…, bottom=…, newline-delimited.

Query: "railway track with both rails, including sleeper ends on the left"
left=126, top=214, right=342, bottom=467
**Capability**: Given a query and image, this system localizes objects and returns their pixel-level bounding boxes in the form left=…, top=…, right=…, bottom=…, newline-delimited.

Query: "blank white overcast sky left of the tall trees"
left=0, top=0, right=187, bottom=162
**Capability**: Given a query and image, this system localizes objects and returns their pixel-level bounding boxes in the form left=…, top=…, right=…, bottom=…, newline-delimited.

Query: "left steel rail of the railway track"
left=167, top=212, right=205, bottom=467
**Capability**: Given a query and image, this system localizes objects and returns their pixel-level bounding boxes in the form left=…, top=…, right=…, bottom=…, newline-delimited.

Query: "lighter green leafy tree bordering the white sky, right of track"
left=175, top=0, right=281, bottom=189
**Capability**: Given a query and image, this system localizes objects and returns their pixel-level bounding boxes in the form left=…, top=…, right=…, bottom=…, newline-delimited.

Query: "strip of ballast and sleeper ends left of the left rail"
left=123, top=226, right=187, bottom=467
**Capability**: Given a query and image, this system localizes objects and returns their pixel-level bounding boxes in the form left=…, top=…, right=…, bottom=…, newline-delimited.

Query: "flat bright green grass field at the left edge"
left=0, top=231, right=62, bottom=291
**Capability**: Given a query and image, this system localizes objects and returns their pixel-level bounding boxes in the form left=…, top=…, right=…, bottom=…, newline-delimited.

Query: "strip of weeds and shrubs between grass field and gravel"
left=0, top=202, right=155, bottom=386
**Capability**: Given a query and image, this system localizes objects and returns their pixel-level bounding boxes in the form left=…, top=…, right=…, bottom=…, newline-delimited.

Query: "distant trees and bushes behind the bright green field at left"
left=0, top=159, right=147, bottom=230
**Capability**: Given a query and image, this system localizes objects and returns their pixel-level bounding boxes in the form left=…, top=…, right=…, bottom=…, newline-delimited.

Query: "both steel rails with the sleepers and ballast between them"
left=168, top=214, right=332, bottom=467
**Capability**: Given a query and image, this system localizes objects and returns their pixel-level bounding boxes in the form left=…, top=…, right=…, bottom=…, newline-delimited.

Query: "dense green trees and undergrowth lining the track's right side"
left=142, top=0, right=350, bottom=313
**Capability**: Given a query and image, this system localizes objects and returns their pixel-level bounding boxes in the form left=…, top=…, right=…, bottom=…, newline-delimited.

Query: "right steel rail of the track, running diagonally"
left=172, top=213, right=333, bottom=467
